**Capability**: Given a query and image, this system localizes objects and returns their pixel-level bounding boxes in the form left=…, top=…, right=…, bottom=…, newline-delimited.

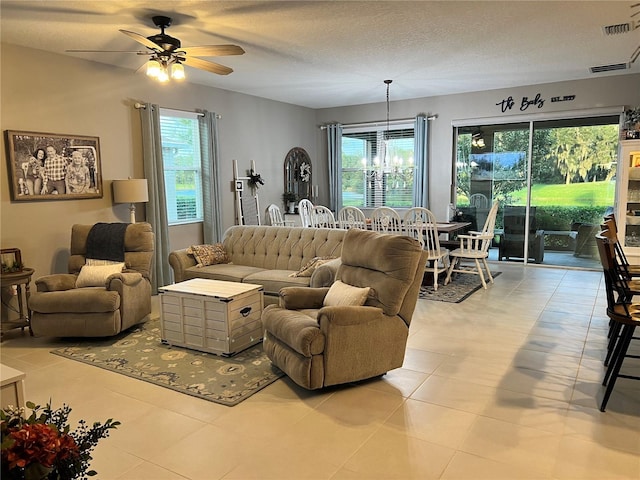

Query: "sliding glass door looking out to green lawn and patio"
left=456, top=115, right=619, bottom=268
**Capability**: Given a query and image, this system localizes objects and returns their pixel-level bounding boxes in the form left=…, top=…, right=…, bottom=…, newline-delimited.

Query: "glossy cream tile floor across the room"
left=1, top=263, right=640, bottom=480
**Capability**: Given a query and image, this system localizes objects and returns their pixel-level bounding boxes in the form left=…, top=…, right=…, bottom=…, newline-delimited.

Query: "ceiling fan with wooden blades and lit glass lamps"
left=67, top=15, right=245, bottom=82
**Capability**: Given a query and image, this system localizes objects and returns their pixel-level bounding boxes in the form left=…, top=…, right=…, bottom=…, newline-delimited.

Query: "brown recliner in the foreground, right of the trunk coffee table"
left=262, top=229, right=427, bottom=390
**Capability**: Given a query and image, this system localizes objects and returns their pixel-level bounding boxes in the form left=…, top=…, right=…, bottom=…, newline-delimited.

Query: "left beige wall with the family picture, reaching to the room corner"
left=0, top=44, right=318, bottom=277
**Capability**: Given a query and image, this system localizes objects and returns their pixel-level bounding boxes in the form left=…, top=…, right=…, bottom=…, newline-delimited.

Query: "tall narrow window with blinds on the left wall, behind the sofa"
left=160, top=109, right=203, bottom=225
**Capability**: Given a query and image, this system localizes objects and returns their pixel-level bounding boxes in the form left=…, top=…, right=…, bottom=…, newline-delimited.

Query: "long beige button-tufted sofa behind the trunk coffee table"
left=169, top=225, right=346, bottom=305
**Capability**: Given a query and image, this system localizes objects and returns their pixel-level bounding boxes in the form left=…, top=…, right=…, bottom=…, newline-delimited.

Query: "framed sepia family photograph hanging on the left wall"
left=5, top=130, right=104, bottom=202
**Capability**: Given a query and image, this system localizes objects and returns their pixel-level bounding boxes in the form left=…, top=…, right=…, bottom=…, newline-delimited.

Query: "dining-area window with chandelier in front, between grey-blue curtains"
left=342, top=125, right=415, bottom=208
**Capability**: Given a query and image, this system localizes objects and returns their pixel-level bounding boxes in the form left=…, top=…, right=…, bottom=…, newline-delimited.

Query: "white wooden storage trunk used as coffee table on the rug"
left=158, top=278, right=263, bottom=356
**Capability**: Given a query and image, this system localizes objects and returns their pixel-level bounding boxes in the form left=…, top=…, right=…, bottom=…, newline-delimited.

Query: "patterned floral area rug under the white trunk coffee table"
left=51, top=320, right=284, bottom=406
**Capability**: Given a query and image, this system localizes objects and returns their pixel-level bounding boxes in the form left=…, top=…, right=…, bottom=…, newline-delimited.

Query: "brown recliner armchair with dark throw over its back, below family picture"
left=29, top=223, right=154, bottom=337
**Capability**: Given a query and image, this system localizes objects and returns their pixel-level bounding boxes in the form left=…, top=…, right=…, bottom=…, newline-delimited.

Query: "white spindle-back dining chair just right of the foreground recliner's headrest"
left=402, top=207, right=449, bottom=290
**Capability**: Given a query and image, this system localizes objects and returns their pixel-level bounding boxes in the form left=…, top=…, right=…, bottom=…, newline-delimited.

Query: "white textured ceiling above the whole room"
left=0, top=0, right=640, bottom=108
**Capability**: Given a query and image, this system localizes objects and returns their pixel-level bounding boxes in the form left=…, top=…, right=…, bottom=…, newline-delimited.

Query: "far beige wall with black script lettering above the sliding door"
left=316, top=74, right=640, bottom=218
